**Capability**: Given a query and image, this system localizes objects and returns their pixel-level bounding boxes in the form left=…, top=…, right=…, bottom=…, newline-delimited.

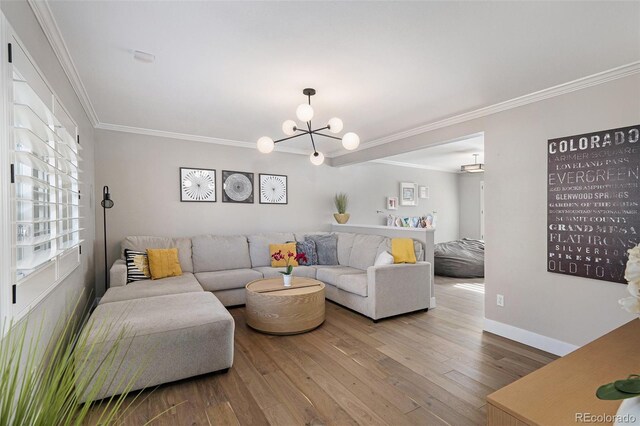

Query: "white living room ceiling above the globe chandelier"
left=49, top=0, right=640, bottom=155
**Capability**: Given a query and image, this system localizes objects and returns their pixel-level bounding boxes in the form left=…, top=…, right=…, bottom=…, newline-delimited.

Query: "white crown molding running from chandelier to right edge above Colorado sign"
left=350, top=61, right=640, bottom=155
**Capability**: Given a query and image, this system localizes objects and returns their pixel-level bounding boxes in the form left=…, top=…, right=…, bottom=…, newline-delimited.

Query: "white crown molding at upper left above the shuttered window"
left=27, top=0, right=100, bottom=127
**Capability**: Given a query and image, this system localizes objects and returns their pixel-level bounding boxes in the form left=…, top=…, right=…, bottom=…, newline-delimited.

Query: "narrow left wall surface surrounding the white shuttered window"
left=0, top=1, right=95, bottom=336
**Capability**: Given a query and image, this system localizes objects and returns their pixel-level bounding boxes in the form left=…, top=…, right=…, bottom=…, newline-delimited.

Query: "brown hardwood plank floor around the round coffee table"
left=87, top=277, right=556, bottom=426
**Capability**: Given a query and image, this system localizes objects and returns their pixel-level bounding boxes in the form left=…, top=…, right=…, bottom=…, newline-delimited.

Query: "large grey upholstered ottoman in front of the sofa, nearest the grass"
left=75, top=291, right=235, bottom=402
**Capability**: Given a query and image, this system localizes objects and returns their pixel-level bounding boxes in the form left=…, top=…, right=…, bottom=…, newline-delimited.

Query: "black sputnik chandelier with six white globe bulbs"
left=258, top=88, right=360, bottom=166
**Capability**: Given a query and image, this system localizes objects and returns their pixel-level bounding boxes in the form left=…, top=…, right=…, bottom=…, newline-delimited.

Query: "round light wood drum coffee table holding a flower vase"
left=245, top=277, right=325, bottom=334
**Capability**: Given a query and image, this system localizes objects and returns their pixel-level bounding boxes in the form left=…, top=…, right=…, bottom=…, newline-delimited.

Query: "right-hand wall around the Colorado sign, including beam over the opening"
left=334, top=74, right=640, bottom=345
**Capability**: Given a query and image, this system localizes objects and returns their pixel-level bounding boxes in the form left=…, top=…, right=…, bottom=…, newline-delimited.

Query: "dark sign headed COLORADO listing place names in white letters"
left=547, top=125, right=640, bottom=283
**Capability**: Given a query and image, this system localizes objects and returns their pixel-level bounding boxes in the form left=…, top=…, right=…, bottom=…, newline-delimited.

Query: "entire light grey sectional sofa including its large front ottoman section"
left=76, top=233, right=431, bottom=401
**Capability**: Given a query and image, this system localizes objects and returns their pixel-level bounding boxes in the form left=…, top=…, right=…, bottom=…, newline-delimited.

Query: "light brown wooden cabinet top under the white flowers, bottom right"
left=487, top=319, right=640, bottom=426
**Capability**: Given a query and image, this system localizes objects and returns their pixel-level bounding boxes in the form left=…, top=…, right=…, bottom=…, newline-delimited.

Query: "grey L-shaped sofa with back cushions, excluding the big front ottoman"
left=107, top=232, right=431, bottom=320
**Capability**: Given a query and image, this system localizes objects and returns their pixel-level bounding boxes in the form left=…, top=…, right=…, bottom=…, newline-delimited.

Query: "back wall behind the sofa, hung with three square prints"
left=95, top=130, right=458, bottom=293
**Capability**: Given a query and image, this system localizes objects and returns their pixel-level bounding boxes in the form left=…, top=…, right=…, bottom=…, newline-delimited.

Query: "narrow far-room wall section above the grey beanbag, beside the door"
left=458, top=173, right=484, bottom=239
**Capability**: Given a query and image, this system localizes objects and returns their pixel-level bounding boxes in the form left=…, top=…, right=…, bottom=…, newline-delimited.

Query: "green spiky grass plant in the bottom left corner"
left=0, top=294, right=168, bottom=426
